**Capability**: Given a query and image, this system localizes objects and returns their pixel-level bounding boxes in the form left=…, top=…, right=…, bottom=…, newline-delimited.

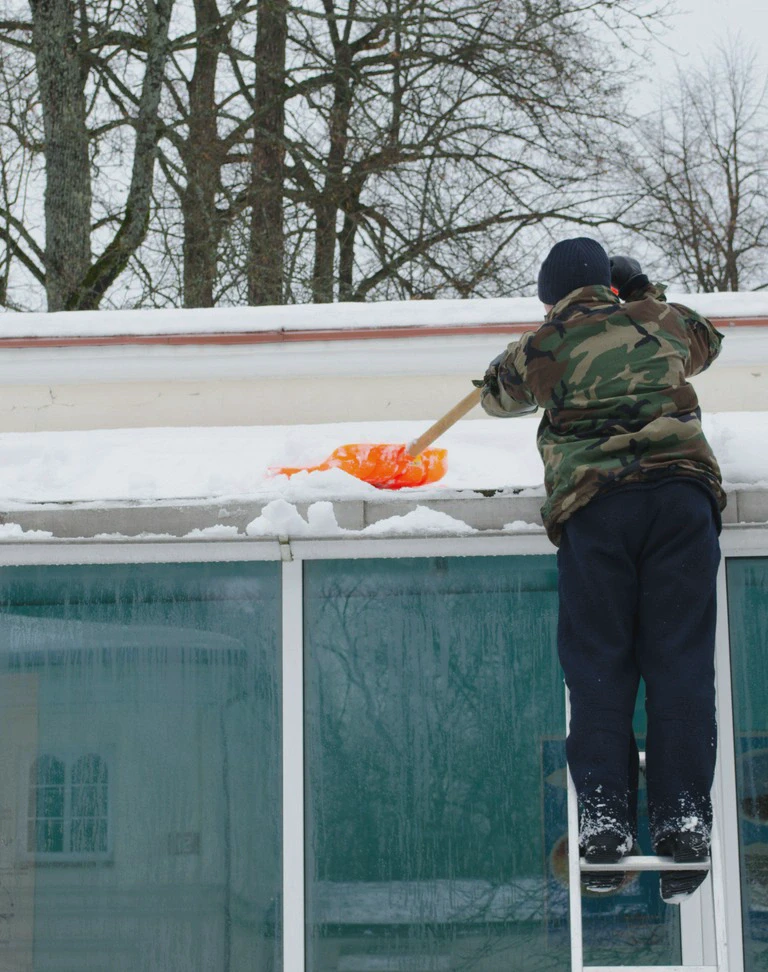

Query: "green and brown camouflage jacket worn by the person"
left=482, top=285, right=725, bottom=544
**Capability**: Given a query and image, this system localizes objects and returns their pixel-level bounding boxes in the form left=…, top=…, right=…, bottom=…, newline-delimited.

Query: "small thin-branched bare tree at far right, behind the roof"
left=625, top=43, right=768, bottom=292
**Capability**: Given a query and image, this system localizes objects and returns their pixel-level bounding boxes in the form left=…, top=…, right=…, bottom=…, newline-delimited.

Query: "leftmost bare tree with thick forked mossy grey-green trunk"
left=0, top=0, right=173, bottom=310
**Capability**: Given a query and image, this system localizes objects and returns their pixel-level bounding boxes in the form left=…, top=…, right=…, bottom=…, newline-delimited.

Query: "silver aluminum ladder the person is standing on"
left=565, top=686, right=728, bottom=972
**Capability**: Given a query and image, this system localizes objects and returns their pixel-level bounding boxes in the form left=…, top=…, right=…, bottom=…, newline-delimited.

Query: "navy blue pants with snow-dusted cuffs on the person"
left=557, top=477, right=720, bottom=845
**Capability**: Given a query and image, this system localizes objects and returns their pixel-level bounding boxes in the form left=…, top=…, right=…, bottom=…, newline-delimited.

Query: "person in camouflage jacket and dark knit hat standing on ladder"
left=481, top=237, right=725, bottom=902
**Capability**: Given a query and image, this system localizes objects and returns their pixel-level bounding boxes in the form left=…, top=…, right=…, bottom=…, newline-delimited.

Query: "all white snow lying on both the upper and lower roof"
left=0, top=293, right=768, bottom=540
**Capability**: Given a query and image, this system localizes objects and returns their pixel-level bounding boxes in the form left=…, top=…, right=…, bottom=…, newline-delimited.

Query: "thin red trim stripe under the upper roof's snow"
left=0, top=317, right=768, bottom=350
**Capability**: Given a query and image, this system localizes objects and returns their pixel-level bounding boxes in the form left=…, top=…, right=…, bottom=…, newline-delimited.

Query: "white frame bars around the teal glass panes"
left=0, top=524, right=768, bottom=972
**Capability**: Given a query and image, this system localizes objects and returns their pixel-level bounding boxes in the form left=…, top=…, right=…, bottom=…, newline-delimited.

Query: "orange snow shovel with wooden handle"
left=270, top=388, right=480, bottom=489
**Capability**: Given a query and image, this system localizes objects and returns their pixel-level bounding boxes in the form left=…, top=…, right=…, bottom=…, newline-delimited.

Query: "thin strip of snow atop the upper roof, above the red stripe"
left=0, top=292, right=768, bottom=339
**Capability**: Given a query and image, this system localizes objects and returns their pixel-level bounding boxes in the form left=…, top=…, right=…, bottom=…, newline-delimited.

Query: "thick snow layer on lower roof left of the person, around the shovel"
left=0, top=419, right=542, bottom=509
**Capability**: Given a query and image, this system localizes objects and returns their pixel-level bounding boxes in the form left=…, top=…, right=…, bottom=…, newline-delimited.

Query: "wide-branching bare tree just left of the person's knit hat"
left=280, top=0, right=660, bottom=301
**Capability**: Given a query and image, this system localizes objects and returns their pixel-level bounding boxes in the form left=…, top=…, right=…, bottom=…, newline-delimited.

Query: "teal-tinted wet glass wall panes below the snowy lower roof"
left=10, top=544, right=768, bottom=972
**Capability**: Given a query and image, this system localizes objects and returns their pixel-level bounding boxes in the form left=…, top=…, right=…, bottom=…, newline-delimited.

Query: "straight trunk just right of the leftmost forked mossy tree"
left=181, top=0, right=224, bottom=307
